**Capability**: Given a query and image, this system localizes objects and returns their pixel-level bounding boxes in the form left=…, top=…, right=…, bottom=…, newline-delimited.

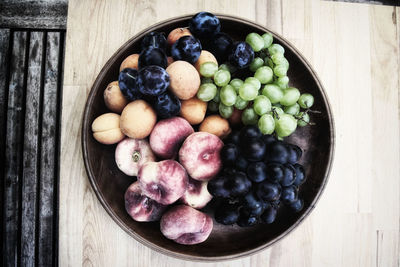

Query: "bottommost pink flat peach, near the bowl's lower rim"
left=160, top=205, right=213, bottom=245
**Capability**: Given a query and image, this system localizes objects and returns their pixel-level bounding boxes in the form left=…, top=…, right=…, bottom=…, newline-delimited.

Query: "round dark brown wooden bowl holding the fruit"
left=82, top=14, right=334, bottom=261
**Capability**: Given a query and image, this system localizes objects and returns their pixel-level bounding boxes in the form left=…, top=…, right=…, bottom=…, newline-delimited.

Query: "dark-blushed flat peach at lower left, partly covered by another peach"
left=124, top=181, right=167, bottom=222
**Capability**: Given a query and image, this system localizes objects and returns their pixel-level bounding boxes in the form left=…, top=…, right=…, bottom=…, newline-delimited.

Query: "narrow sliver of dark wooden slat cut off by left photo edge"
left=0, top=29, right=10, bottom=260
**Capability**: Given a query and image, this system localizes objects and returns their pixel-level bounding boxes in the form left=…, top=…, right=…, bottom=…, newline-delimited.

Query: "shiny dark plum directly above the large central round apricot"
left=171, top=35, right=202, bottom=64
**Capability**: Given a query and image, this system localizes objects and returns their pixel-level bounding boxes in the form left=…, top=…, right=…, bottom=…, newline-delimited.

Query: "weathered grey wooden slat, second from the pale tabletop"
left=21, top=32, right=44, bottom=266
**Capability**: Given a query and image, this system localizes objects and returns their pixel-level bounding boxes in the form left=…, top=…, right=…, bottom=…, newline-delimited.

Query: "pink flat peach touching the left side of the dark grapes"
left=179, top=132, right=224, bottom=181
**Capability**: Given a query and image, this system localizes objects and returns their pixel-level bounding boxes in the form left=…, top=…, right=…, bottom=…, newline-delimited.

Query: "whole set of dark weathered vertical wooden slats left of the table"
left=0, top=29, right=65, bottom=266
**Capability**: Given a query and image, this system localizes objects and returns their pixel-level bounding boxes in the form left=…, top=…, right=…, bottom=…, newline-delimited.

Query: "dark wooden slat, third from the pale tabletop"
left=2, top=31, right=29, bottom=266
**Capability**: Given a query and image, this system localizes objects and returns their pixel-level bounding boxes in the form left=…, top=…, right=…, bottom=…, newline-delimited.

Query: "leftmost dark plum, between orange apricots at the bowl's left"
left=118, top=68, right=142, bottom=101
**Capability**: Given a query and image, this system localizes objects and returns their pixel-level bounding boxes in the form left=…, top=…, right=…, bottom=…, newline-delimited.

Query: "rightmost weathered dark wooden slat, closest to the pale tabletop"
left=37, top=32, right=63, bottom=266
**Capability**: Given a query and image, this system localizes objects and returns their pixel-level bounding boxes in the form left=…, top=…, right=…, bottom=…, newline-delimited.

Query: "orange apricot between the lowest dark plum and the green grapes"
left=180, top=97, right=207, bottom=125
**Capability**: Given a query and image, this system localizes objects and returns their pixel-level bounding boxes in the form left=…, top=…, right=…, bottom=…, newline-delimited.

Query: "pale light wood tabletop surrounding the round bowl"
left=59, top=0, right=400, bottom=266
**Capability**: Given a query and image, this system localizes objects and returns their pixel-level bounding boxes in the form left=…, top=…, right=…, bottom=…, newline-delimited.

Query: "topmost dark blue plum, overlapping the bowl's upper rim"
left=189, top=12, right=221, bottom=38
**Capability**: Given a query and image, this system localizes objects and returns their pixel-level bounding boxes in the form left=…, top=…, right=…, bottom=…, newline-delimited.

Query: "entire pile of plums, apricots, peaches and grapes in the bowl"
left=92, top=12, right=314, bottom=245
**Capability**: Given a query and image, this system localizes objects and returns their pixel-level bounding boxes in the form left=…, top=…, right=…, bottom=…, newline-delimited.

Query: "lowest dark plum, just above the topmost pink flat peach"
left=153, top=91, right=181, bottom=119
